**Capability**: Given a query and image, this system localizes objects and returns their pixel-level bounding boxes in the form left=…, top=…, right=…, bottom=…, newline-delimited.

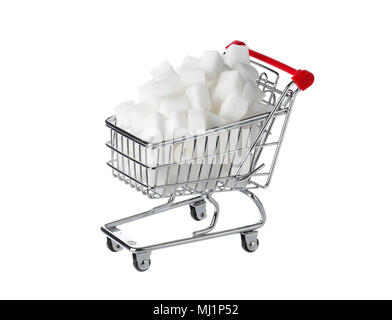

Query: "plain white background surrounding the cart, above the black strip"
left=0, top=0, right=392, bottom=299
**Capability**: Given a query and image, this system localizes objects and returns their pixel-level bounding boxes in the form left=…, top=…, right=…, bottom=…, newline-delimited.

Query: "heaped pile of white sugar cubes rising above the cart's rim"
left=115, top=45, right=272, bottom=143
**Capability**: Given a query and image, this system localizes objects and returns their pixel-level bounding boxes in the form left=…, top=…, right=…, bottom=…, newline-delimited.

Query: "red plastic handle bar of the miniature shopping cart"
left=226, top=40, right=314, bottom=90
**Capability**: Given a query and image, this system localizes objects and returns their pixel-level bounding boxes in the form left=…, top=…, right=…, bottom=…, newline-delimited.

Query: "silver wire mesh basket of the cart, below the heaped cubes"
left=106, top=61, right=294, bottom=198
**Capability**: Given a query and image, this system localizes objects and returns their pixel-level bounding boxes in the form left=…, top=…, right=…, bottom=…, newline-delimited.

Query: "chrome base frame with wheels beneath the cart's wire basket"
left=101, top=188, right=266, bottom=271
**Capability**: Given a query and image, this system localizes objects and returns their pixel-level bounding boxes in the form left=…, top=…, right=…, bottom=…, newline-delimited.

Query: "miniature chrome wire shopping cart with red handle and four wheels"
left=101, top=41, right=314, bottom=271
